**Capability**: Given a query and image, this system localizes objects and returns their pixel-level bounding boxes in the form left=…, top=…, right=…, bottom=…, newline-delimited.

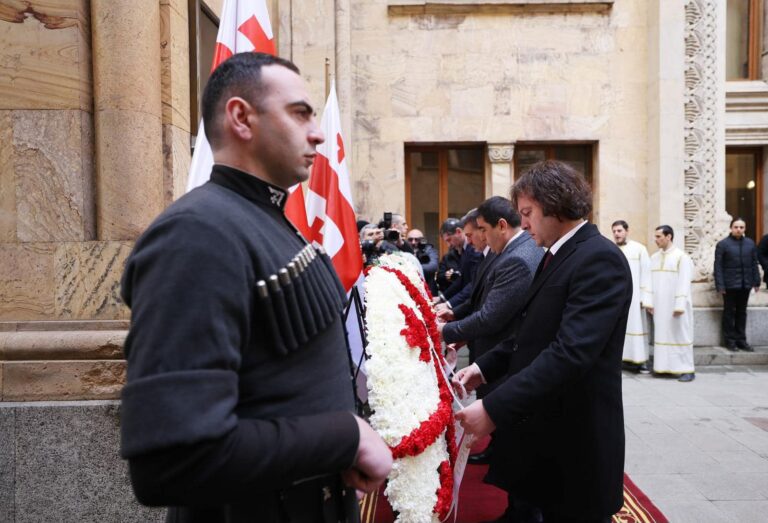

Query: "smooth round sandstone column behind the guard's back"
left=91, top=0, right=163, bottom=240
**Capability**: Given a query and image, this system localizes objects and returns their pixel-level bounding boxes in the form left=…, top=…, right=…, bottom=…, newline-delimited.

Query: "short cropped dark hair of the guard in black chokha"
left=201, top=52, right=299, bottom=147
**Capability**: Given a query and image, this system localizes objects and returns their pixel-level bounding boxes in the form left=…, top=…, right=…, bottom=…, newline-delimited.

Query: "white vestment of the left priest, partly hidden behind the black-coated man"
left=619, top=240, right=653, bottom=363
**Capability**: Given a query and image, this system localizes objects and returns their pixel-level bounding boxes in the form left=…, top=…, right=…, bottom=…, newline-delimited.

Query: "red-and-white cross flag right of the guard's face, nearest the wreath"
left=306, top=84, right=363, bottom=292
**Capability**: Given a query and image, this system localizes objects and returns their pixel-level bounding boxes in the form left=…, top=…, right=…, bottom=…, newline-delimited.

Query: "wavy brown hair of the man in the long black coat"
left=512, top=160, right=592, bottom=220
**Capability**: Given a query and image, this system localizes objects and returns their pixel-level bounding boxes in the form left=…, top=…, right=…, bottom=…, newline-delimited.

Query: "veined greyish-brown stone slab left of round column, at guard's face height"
left=12, top=111, right=95, bottom=242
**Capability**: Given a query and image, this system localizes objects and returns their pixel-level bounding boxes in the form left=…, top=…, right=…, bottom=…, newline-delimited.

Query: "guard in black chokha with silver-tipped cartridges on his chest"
left=122, top=53, right=392, bottom=522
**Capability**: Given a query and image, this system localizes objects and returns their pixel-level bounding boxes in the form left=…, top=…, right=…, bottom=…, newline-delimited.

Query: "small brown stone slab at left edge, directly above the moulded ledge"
left=0, top=243, right=55, bottom=320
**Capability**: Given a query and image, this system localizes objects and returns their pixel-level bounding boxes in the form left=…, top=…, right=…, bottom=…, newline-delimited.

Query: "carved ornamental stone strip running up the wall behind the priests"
left=684, top=0, right=730, bottom=279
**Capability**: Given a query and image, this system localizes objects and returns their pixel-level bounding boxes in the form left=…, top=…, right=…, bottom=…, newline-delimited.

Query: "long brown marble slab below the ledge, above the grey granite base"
left=2, top=360, right=125, bottom=401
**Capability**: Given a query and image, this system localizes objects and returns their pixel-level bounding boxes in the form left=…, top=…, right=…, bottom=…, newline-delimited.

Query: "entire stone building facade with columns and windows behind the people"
left=0, top=0, right=768, bottom=521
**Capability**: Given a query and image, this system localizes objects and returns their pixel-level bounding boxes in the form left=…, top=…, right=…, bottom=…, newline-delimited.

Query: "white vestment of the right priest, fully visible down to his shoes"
left=651, top=245, right=694, bottom=374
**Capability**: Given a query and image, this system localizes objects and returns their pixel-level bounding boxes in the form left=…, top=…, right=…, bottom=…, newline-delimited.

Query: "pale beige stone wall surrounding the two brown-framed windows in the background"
left=288, top=0, right=649, bottom=241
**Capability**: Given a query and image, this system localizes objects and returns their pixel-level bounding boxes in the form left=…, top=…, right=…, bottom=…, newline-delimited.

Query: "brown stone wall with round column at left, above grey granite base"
left=0, top=0, right=190, bottom=401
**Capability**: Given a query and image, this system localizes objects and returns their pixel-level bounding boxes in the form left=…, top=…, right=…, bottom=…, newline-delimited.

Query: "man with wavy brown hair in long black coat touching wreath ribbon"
left=454, top=160, right=632, bottom=523
